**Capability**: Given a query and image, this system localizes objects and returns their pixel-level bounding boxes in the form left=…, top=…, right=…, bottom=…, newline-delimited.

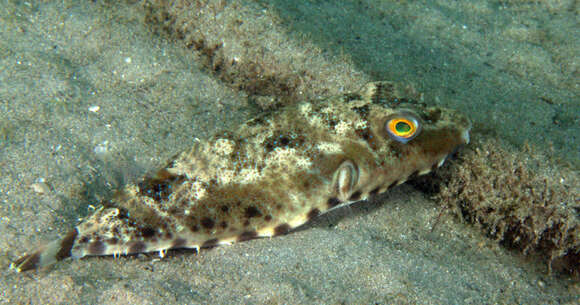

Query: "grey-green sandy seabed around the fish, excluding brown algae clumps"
left=0, top=1, right=580, bottom=304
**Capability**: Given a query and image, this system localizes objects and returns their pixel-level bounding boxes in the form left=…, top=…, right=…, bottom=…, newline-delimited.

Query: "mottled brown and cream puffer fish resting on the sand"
left=12, top=82, right=471, bottom=271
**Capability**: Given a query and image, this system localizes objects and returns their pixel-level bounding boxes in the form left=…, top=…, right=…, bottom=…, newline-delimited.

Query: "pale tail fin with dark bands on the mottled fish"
left=10, top=229, right=78, bottom=272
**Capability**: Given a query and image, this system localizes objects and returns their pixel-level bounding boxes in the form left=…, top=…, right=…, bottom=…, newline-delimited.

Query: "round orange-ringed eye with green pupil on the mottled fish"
left=385, top=110, right=421, bottom=144
